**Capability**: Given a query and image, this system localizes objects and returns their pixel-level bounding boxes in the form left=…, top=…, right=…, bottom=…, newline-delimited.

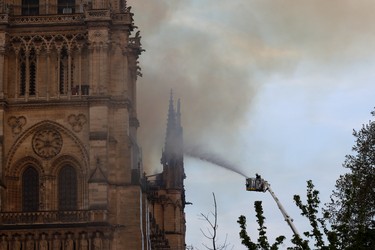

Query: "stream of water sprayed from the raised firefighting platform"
left=184, top=146, right=247, bottom=178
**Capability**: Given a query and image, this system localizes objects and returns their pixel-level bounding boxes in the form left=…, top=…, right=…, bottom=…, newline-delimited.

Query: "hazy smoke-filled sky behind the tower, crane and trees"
left=128, top=0, right=375, bottom=249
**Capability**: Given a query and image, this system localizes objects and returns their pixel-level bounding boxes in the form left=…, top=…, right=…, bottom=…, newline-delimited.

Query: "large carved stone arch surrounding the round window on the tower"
left=5, top=120, right=89, bottom=176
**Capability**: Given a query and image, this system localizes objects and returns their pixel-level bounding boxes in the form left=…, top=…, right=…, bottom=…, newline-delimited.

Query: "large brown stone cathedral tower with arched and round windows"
left=0, top=0, right=184, bottom=250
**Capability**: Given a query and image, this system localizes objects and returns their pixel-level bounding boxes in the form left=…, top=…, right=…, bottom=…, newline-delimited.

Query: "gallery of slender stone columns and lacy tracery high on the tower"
left=8, top=31, right=87, bottom=98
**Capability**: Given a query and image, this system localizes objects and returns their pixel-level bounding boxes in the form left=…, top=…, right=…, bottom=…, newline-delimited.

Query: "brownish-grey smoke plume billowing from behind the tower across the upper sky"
left=128, top=0, right=375, bottom=174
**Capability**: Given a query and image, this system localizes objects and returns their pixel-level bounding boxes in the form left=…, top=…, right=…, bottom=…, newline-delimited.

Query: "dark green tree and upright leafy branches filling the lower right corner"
left=238, top=111, right=375, bottom=250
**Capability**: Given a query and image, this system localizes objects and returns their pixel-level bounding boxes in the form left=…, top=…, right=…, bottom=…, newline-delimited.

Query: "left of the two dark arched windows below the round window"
left=22, top=166, right=39, bottom=211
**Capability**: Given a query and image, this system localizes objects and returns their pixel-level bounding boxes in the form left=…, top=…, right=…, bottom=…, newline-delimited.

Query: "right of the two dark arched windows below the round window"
left=59, top=165, right=77, bottom=210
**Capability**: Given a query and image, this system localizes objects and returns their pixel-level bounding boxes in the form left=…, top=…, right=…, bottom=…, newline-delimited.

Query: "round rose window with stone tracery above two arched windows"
left=32, top=129, right=63, bottom=159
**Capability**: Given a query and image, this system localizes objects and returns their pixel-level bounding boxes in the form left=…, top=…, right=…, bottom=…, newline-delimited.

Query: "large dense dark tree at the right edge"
left=326, top=112, right=375, bottom=249
